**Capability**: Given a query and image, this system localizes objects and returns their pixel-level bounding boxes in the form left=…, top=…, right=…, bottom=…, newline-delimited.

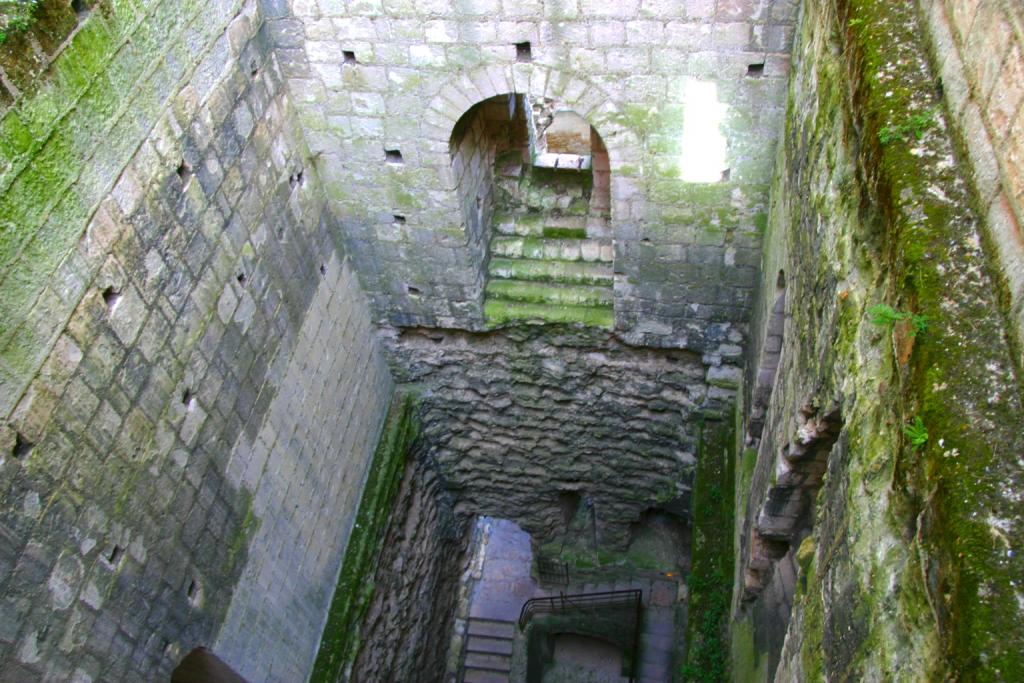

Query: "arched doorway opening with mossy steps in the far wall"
left=449, top=93, right=613, bottom=328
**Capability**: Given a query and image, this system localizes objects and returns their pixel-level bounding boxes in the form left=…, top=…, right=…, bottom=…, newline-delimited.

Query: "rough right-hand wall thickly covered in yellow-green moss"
left=733, top=0, right=1024, bottom=681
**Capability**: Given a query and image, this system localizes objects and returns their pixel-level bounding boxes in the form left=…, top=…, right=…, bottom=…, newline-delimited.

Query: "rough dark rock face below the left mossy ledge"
left=345, top=460, right=467, bottom=681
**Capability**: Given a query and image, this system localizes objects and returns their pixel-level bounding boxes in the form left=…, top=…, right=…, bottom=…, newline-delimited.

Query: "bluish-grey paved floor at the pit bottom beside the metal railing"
left=469, top=519, right=679, bottom=683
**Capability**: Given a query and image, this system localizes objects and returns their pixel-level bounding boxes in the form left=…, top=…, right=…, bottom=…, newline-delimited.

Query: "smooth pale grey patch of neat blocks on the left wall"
left=213, top=255, right=392, bottom=682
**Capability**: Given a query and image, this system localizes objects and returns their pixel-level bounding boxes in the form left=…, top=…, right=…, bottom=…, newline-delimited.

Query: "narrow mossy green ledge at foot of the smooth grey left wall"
left=309, top=392, right=419, bottom=682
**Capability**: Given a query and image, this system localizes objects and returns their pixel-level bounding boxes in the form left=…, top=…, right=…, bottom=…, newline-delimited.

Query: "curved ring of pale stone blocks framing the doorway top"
left=424, top=63, right=640, bottom=220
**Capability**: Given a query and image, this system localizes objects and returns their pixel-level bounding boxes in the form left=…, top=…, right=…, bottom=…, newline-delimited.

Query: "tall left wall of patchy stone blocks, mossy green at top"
left=0, top=2, right=388, bottom=682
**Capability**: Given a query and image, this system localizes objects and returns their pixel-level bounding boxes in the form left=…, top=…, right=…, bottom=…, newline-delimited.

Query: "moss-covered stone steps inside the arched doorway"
left=483, top=213, right=613, bottom=329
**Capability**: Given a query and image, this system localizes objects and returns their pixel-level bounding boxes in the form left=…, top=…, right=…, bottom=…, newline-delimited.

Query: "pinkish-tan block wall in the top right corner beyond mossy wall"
left=920, top=0, right=1024, bottom=366
